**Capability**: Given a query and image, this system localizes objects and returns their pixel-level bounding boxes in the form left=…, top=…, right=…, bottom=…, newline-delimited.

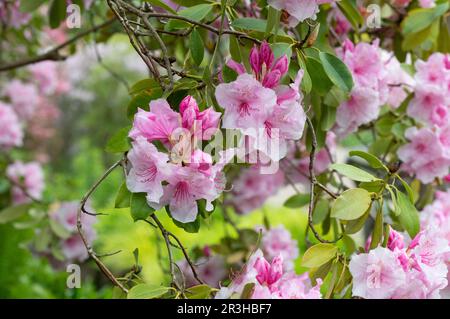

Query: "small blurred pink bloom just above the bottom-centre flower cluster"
left=261, top=225, right=299, bottom=271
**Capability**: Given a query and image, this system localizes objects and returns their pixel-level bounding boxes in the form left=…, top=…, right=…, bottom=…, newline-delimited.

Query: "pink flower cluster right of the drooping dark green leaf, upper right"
left=336, top=39, right=412, bottom=135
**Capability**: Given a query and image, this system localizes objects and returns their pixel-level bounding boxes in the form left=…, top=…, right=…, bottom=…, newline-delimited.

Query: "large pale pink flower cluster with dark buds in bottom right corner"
left=349, top=228, right=450, bottom=299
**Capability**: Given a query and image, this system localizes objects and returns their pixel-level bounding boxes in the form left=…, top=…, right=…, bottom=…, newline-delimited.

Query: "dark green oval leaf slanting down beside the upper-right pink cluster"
left=319, top=52, right=353, bottom=92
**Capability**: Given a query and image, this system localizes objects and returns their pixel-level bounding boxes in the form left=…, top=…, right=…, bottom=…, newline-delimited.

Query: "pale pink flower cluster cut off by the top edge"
left=267, top=0, right=336, bottom=27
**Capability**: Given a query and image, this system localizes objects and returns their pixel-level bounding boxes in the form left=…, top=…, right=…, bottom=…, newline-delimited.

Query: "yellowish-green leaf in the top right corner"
left=401, top=1, right=449, bottom=35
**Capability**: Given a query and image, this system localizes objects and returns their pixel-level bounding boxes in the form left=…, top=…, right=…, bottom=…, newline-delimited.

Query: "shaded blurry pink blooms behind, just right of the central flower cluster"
left=229, top=165, right=284, bottom=214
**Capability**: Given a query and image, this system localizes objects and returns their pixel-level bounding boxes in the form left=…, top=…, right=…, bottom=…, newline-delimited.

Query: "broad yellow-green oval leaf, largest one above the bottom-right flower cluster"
left=331, top=188, right=372, bottom=220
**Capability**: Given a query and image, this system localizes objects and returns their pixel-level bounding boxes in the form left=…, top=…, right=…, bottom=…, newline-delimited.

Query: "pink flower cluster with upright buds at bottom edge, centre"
left=216, top=250, right=322, bottom=299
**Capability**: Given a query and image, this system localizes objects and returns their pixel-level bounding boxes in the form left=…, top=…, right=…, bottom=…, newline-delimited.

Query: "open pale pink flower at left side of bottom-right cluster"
left=349, top=247, right=406, bottom=299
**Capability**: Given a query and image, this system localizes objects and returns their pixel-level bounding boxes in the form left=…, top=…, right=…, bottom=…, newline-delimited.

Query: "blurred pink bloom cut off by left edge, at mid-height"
left=0, top=102, right=23, bottom=149
